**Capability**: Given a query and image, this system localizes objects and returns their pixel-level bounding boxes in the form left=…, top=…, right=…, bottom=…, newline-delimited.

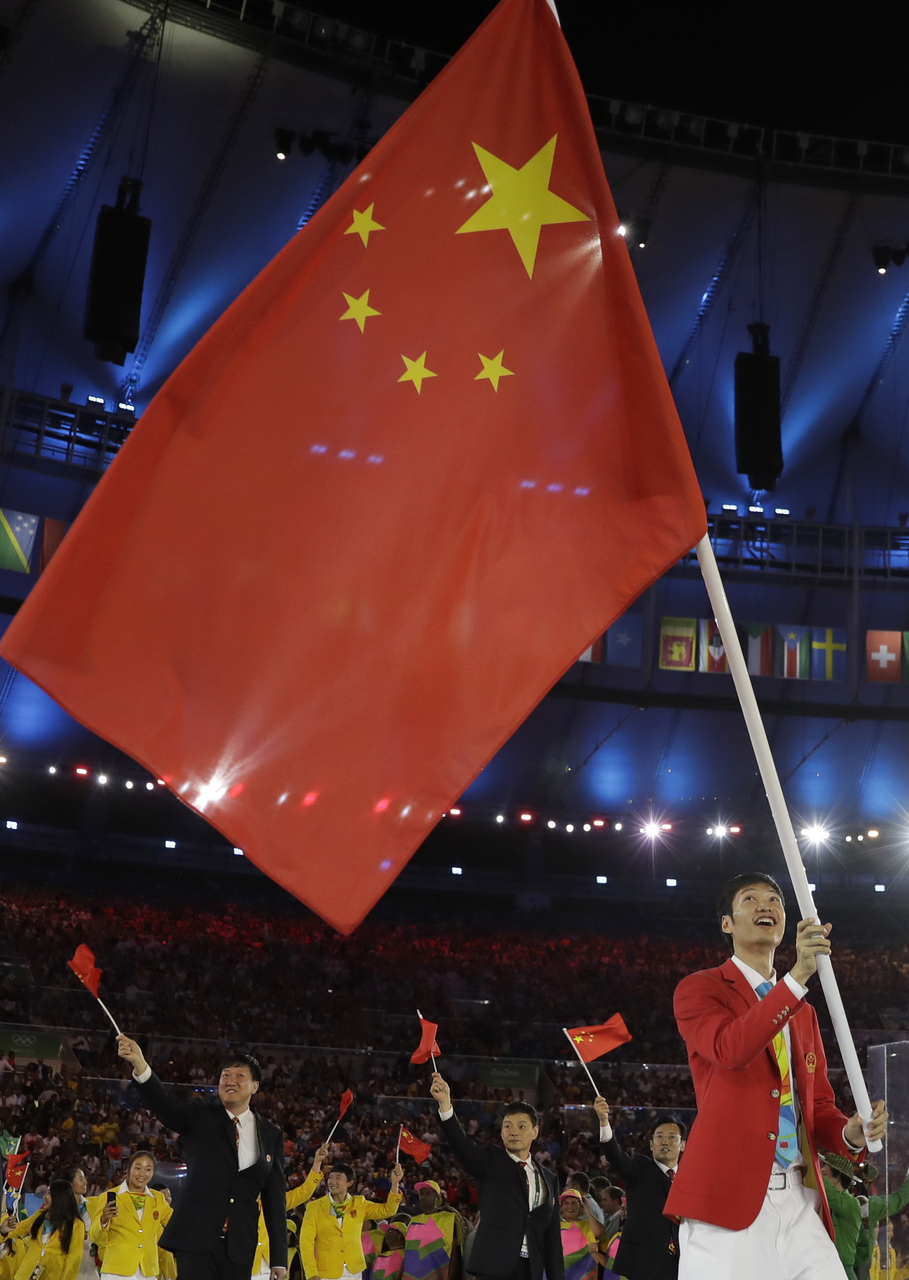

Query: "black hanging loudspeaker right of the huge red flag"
left=735, top=324, right=782, bottom=490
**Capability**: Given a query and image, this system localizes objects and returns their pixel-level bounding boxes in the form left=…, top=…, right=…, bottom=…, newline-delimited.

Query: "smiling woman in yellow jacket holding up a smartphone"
left=88, top=1151, right=172, bottom=1280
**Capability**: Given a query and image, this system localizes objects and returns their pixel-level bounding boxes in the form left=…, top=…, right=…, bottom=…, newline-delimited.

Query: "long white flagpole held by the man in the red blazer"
left=698, top=534, right=881, bottom=1151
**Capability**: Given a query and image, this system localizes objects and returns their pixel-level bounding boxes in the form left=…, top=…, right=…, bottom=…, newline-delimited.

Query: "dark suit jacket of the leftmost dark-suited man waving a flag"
left=133, top=1074, right=287, bottom=1271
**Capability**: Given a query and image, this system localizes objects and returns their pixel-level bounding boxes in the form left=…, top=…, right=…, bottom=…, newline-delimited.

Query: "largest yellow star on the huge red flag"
left=457, top=134, right=590, bottom=278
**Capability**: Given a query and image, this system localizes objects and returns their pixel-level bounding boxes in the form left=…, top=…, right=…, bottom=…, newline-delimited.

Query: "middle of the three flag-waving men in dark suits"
left=430, top=1071, right=565, bottom=1280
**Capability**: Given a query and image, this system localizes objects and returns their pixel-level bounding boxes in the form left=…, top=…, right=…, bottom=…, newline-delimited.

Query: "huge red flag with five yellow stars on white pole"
left=1, top=0, right=705, bottom=931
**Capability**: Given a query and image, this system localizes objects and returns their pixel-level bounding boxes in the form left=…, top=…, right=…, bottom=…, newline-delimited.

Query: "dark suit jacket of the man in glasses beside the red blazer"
left=603, top=1135, right=679, bottom=1280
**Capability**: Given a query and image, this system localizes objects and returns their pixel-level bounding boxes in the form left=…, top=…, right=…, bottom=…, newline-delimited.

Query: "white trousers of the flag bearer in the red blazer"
left=679, top=1175, right=845, bottom=1280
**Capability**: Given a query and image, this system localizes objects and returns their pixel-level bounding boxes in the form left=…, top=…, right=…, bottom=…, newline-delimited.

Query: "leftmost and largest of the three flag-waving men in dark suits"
left=118, top=1036, right=287, bottom=1280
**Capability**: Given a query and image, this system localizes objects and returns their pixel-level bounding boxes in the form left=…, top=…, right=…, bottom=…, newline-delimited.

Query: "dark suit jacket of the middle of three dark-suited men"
left=442, top=1116, right=565, bottom=1280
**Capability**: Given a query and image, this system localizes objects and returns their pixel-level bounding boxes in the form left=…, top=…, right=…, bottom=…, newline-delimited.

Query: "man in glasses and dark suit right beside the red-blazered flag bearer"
left=594, top=1098, right=685, bottom=1280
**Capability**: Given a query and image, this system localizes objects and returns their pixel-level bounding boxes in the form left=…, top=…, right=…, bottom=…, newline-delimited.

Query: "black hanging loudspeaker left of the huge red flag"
left=83, top=178, right=151, bottom=365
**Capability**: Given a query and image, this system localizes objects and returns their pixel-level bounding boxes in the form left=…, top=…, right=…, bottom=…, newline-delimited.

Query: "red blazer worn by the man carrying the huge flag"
left=664, top=960, right=849, bottom=1238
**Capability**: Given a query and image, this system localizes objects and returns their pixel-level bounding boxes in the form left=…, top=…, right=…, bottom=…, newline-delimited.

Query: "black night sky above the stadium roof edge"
left=314, top=0, right=909, bottom=143
